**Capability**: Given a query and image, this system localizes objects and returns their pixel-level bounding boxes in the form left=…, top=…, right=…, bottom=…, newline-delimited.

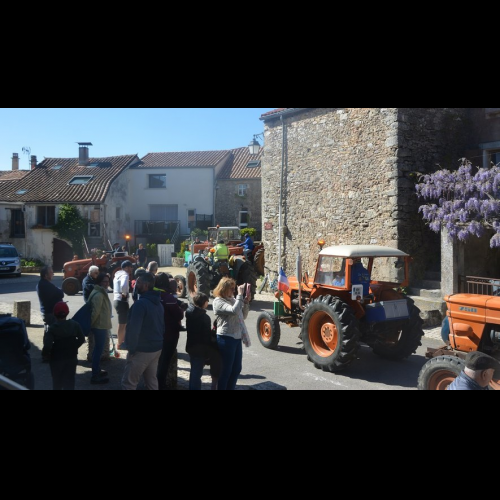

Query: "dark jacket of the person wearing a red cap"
left=42, top=319, right=85, bottom=361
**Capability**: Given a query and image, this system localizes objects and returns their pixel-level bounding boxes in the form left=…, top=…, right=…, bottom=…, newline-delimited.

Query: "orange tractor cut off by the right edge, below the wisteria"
left=418, top=286, right=500, bottom=391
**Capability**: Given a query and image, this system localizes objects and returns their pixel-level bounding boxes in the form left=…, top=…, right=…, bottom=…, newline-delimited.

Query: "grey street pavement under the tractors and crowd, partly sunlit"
left=0, top=267, right=442, bottom=390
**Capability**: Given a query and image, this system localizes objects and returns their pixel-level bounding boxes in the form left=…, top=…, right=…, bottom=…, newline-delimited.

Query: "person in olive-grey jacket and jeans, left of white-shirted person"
left=89, top=273, right=112, bottom=384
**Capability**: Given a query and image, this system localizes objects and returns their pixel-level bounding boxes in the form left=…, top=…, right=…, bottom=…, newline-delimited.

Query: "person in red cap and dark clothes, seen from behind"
left=42, top=302, right=85, bottom=391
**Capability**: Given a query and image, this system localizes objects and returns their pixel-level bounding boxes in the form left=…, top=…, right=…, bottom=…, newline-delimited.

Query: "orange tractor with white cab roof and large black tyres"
left=257, top=241, right=424, bottom=372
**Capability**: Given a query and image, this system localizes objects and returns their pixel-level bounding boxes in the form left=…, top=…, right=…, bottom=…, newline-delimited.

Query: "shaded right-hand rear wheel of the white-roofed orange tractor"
left=373, top=298, right=424, bottom=361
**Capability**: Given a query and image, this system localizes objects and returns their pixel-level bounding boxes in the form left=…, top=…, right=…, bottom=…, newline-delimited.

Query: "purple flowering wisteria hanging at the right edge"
left=416, top=159, right=500, bottom=248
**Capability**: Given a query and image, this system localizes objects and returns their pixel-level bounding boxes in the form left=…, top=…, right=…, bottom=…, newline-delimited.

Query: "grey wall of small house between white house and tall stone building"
left=215, top=179, right=262, bottom=233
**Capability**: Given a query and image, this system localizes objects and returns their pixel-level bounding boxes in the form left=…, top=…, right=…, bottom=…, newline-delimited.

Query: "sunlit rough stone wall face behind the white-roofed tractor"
left=262, top=108, right=398, bottom=274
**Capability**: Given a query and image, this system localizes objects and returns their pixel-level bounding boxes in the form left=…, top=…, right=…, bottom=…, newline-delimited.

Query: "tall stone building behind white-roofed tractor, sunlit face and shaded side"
left=261, top=108, right=466, bottom=279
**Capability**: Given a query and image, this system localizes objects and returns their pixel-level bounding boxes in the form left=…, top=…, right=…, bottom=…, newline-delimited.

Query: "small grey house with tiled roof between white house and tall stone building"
left=215, top=147, right=262, bottom=239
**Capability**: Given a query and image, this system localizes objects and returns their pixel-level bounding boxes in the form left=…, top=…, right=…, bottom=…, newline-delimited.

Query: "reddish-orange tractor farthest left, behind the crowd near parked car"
left=62, top=252, right=137, bottom=295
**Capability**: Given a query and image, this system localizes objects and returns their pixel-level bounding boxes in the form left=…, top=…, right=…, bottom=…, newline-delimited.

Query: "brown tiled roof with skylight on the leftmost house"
left=0, top=155, right=139, bottom=204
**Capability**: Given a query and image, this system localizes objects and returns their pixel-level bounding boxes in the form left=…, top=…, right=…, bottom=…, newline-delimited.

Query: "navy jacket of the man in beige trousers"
left=125, top=291, right=165, bottom=354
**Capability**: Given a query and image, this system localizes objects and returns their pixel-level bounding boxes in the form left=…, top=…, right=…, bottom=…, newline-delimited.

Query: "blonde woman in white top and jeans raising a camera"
left=214, top=278, right=250, bottom=391
